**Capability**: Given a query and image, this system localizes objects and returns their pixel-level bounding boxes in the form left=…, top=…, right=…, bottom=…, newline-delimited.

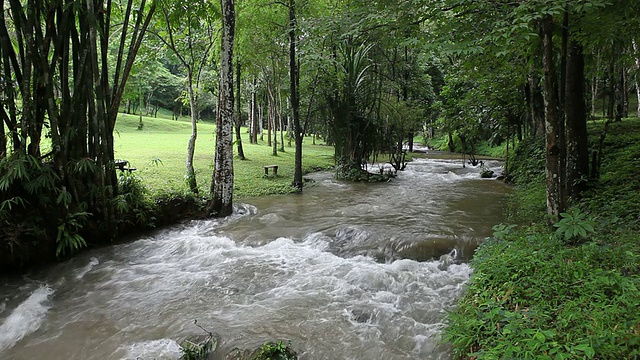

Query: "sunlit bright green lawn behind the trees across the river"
left=114, top=114, right=334, bottom=198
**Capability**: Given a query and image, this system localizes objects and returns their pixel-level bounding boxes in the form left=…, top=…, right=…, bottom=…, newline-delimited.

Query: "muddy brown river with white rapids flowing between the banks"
left=0, top=160, right=509, bottom=360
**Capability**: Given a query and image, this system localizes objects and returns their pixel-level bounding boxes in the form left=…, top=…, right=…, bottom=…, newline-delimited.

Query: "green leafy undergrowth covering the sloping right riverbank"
left=445, top=119, right=640, bottom=359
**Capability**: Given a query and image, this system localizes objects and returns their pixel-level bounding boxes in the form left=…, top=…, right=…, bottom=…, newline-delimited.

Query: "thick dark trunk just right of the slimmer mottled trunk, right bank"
left=565, top=40, right=589, bottom=200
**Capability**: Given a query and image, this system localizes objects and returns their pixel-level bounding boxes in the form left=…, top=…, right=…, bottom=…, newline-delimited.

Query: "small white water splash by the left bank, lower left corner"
left=0, top=285, right=53, bottom=351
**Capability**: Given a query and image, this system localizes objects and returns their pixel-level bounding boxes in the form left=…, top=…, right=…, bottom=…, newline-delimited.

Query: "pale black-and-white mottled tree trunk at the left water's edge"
left=209, top=0, right=235, bottom=216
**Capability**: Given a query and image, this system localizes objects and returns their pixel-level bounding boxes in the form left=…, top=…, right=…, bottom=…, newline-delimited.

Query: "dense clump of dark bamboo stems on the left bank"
left=0, top=0, right=155, bottom=254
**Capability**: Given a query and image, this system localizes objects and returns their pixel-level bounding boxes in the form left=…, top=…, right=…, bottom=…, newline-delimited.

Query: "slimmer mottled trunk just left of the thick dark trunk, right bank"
left=541, top=15, right=564, bottom=222
